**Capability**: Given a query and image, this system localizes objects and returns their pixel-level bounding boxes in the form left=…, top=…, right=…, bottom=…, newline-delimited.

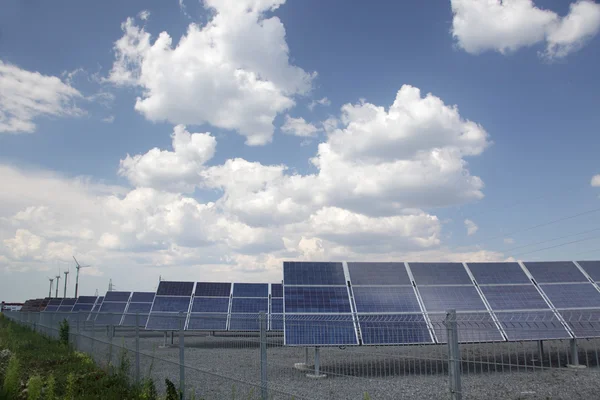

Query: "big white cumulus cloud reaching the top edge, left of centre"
left=108, top=0, right=313, bottom=145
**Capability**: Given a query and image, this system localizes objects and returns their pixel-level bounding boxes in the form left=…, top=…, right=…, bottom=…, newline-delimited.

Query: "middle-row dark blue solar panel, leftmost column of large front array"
left=284, top=286, right=351, bottom=313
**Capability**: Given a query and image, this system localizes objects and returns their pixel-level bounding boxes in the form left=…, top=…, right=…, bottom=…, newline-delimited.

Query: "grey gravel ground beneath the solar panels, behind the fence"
left=71, top=330, right=600, bottom=400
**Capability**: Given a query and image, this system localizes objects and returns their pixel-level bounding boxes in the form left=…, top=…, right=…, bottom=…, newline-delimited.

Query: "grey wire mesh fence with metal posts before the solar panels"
left=5, top=310, right=600, bottom=400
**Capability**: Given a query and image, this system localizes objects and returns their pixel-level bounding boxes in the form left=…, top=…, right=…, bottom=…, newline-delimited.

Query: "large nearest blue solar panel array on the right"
left=283, top=261, right=600, bottom=346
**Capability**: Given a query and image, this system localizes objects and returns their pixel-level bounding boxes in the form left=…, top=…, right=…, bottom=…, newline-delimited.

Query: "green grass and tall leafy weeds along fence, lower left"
left=0, top=314, right=154, bottom=400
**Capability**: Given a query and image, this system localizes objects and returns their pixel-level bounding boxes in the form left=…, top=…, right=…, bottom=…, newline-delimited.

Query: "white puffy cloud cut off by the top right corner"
left=451, top=0, right=600, bottom=58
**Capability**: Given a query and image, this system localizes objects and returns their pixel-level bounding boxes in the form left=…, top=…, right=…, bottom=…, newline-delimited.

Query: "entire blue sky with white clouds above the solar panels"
left=0, top=0, right=600, bottom=299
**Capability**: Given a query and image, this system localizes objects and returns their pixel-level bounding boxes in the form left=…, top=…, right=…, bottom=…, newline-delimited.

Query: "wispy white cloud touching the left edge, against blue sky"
left=0, top=60, right=85, bottom=133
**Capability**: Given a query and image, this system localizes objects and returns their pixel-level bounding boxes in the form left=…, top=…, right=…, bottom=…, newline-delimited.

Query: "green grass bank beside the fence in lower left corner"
left=0, top=315, right=141, bottom=400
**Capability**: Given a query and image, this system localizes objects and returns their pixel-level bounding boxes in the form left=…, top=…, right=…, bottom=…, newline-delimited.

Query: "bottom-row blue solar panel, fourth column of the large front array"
left=494, top=310, right=571, bottom=341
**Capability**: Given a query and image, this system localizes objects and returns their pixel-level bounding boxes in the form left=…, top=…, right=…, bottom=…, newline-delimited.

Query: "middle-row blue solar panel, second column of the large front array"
left=353, top=286, right=421, bottom=313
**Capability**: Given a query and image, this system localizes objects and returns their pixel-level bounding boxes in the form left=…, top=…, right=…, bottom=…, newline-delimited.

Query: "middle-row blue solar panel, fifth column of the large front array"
left=541, top=283, right=600, bottom=308
